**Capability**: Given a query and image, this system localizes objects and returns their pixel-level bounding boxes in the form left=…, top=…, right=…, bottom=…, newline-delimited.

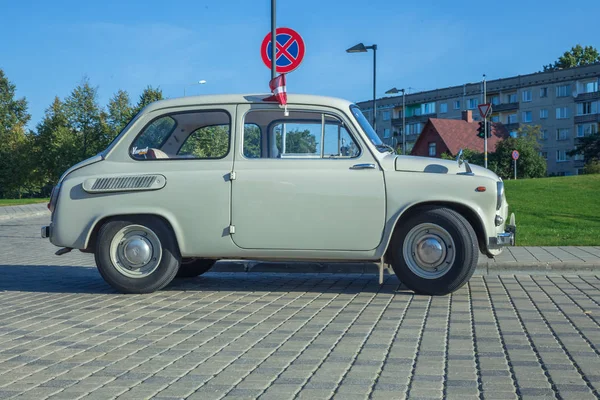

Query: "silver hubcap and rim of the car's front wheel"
left=402, top=223, right=455, bottom=279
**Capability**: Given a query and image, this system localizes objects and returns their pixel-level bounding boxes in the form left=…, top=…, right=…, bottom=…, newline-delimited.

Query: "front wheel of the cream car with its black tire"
left=390, top=207, right=479, bottom=295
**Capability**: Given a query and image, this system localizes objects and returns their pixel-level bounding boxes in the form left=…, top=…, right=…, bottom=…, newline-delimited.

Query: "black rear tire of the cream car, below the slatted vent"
left=95, top=216, right=181, bottom=293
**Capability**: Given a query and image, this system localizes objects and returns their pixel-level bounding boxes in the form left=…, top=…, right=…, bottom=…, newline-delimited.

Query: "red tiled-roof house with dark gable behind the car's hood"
left=410, top=111, right=509, bottom=158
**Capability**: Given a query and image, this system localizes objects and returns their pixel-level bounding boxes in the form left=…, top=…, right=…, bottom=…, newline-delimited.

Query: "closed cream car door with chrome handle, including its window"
left=231, top=104, right=385, bottom=250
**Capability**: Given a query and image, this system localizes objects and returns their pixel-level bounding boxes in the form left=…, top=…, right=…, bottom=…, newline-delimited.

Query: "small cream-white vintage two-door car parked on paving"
left=42, top=94, right=516, bottom=295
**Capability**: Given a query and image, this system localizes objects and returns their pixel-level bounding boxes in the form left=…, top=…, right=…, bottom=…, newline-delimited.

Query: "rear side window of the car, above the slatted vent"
left=130, top=110, right=231, bottom=160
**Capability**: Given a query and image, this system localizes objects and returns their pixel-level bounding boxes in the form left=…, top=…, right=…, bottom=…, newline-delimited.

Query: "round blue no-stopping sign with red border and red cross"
left=260, top=28, right=305, bottom=74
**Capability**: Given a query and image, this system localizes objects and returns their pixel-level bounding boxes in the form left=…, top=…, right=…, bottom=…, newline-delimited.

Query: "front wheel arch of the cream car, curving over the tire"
left=383, top=200, right=486, bottom=263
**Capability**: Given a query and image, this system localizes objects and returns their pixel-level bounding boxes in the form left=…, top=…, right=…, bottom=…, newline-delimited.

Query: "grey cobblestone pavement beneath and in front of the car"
left=0, top=219, right=600, bottom=400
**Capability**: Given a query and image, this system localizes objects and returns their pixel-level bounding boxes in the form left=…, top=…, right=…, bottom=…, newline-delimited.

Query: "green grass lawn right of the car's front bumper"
left=504, top=174, right=600, bottom=246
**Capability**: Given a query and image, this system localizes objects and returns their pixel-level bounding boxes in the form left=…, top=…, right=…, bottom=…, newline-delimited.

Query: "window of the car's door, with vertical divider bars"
left=243, top=110, right=360, bottom=159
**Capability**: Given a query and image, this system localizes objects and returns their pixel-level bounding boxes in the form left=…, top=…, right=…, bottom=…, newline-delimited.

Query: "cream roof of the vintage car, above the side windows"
left=144, top=93, right=354, bottom=112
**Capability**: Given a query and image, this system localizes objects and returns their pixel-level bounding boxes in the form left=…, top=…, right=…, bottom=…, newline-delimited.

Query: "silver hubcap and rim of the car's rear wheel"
left=110, top=225, right=162, bottom=278
